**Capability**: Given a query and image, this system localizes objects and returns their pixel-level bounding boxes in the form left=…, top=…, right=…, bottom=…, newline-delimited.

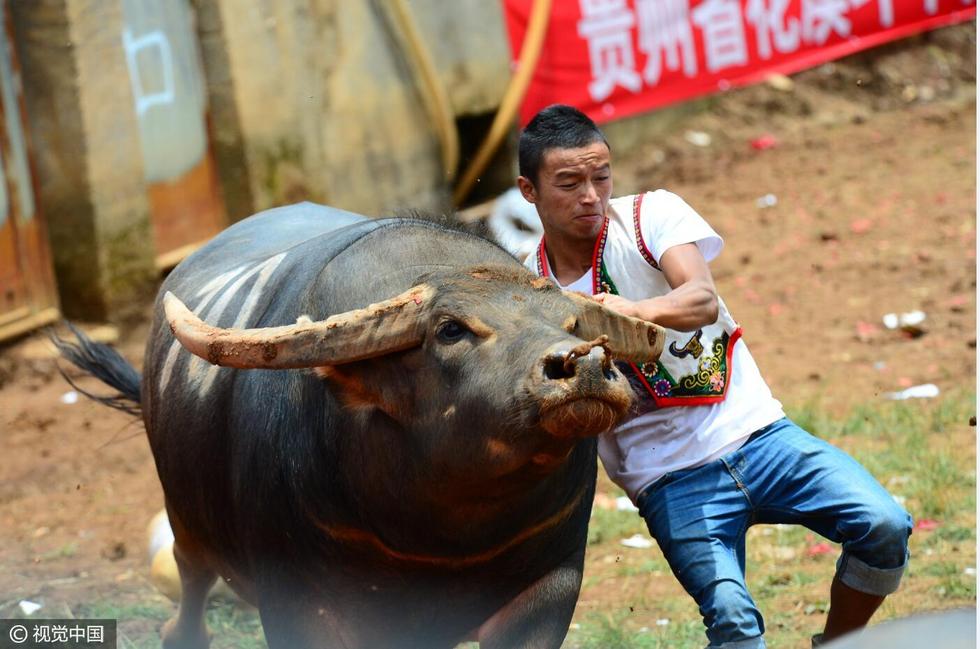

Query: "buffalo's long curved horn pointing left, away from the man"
left=163, top=284, right=434, bottom=369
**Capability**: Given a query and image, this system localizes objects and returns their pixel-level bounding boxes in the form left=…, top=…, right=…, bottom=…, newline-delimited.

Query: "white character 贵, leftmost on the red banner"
left=578, top=0, right=643, bottom=101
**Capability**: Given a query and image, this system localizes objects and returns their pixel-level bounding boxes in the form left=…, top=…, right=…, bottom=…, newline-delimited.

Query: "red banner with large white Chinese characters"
left=503, top=0, right=976, bottom=124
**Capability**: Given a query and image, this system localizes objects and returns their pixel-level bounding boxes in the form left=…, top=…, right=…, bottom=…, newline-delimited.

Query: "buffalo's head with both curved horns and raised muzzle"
left=164, top=266, right=664, bottom=476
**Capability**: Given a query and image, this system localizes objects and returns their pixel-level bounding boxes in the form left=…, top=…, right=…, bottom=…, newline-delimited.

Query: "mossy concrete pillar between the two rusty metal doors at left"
left=10, top=0, right=154, bottom=320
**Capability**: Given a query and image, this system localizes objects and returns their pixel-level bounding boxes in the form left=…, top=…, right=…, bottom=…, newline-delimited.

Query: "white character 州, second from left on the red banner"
left=636, top=0, right=698, bottom=86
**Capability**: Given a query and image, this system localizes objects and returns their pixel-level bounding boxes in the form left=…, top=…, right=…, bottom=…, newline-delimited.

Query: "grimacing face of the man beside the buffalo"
left=517, top=141, right=612, bottom=241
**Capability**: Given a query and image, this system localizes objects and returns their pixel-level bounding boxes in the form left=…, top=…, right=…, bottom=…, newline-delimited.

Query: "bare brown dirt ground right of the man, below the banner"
left=616, top=25, right=976, bottom=416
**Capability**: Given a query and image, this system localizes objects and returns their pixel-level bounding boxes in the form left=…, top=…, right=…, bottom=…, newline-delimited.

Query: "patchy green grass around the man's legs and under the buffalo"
left=67, top=391, right=976, bottom=649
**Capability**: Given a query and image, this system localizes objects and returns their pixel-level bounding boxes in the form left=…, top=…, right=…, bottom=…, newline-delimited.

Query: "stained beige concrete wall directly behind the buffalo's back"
left=195, top=0, right=509, bottom=220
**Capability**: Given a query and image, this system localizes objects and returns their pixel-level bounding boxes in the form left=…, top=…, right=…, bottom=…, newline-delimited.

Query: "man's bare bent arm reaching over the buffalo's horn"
left=594, top=243, right=718, bottom=331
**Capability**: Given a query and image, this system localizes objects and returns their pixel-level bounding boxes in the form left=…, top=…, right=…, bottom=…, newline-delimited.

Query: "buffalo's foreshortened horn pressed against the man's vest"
left=565, top=291, right=666, bottom=363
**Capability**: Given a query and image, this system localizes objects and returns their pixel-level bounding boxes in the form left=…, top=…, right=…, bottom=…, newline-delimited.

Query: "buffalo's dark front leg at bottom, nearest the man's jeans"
left=478, top=549, right=585, bottom=649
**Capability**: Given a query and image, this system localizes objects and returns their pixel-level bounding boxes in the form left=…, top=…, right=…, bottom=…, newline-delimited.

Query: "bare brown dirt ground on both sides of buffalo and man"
left=0, top=25, right=976, bottom=644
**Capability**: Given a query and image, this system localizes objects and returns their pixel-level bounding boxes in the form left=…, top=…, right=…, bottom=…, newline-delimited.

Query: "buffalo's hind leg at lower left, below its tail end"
left=160, top=518, right=217, bottom=649
